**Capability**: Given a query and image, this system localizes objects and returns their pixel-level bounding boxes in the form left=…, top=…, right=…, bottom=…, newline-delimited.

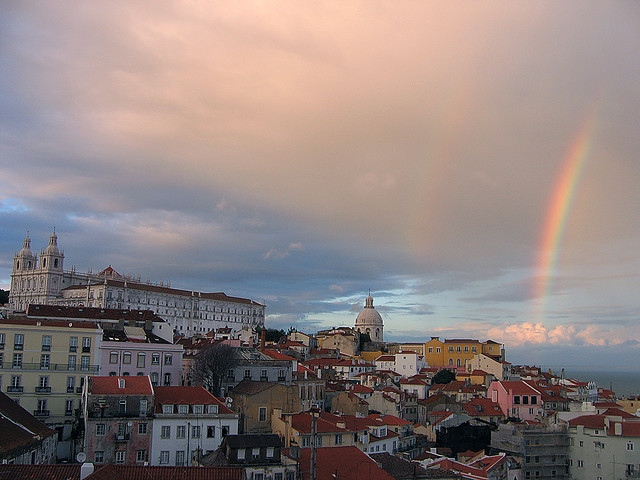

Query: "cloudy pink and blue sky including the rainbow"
left=0, top=0, right=640, bottom=367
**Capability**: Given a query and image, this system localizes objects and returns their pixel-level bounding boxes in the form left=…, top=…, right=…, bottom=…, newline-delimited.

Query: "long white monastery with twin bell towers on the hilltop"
left=9, top=231, right=265, bottom=337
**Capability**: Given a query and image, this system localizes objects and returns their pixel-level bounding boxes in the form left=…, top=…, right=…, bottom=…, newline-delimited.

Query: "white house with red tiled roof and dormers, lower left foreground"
left=149, top=387, right=238, bottom=466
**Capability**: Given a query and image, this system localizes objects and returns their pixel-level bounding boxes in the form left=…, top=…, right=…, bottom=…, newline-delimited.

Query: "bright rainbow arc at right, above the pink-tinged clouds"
left=534, top=109, right=596, bottom=315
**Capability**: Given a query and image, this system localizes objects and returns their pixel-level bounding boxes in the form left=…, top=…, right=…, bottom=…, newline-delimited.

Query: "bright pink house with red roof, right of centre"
left=487, top=381, right=543, bottom=420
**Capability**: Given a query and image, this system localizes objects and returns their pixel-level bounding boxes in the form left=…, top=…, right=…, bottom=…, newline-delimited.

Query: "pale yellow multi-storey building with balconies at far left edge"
left=0, top=317, right=102, bottom=458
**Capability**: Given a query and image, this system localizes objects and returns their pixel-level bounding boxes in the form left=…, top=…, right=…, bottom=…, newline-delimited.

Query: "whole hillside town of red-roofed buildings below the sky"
left=0, top=231, right=640, bottom=480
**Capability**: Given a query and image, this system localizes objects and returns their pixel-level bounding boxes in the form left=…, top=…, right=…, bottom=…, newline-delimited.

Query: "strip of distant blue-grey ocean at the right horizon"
left=542, top=366, right=640, bottom=397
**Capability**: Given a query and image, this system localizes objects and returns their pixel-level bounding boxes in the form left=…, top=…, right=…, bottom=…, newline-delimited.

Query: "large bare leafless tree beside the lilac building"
left=191, top=343, right=239, bottom=396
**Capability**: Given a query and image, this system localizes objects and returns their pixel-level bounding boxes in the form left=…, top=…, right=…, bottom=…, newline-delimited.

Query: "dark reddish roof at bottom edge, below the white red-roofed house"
left=86, top=465, right=244, bottom=480
